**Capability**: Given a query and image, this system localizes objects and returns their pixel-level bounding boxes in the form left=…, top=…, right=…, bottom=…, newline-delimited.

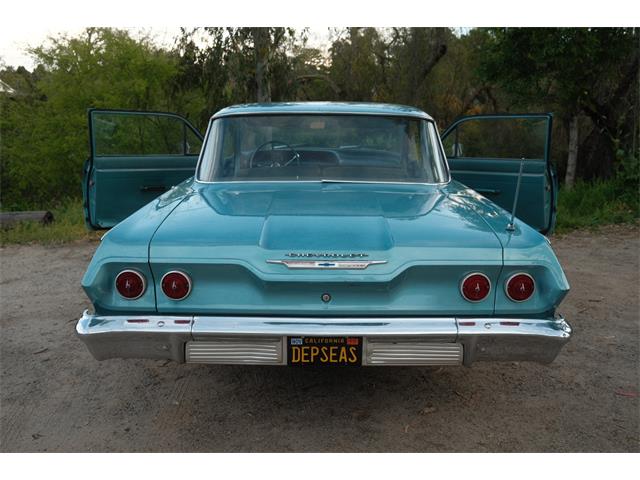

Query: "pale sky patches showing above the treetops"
left=0, top=24, right=329, bottom=70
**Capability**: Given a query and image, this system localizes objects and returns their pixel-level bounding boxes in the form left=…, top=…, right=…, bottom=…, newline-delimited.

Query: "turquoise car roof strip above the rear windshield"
left=213, top=102, right=433, bottom=120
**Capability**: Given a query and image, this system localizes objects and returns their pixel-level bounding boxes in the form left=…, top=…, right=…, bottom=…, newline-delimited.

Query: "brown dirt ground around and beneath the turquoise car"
left=0, top=226, right=640, bottom=452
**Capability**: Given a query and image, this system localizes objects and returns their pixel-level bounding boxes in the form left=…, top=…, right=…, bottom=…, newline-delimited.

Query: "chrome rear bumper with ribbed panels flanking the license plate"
left=76, top=311, right=571, bottom=366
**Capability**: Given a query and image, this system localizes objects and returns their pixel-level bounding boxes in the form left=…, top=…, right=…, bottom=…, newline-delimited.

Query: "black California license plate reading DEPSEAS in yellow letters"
left=287, top=336, right=362, bottom=367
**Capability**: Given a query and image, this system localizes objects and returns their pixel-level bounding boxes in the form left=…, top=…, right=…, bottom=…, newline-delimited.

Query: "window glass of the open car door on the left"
left=92, top=112, right=201, bottom=156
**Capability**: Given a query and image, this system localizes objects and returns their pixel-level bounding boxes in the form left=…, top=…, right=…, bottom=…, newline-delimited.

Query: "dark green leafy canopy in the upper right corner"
left=480, top=28, right=640, bottom=182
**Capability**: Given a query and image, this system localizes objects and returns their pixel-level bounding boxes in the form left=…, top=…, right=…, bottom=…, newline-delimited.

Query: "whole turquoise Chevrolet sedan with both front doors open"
left=76, top=103, right=571, bottom=366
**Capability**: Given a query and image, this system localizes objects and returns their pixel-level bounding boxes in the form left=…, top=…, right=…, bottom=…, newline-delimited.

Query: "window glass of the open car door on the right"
left=444, top=117, right=547, bottom=160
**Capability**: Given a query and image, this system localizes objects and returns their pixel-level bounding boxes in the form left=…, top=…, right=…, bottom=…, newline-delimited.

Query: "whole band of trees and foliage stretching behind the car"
left=0, top=27, right=640, bottom=209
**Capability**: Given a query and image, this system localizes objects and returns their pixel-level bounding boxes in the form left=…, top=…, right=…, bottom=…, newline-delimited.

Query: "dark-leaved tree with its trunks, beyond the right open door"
left=480, top=28, right=638, bottom=188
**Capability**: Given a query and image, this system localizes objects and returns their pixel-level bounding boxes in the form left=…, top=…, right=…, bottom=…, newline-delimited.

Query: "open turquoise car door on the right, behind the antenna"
left=442, top=113, right=558, bottom=233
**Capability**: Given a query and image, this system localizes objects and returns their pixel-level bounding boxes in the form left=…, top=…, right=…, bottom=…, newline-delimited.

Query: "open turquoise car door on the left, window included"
left=82, top=109, right=202, bottom=229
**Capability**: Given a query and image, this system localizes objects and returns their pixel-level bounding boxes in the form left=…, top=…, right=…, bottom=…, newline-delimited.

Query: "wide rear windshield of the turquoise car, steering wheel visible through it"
left=198, top=114, right=448, bottom=183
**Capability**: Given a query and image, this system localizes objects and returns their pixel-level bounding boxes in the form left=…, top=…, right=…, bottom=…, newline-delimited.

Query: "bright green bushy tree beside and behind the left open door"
left=0, top=28, right=184, bottom=208
